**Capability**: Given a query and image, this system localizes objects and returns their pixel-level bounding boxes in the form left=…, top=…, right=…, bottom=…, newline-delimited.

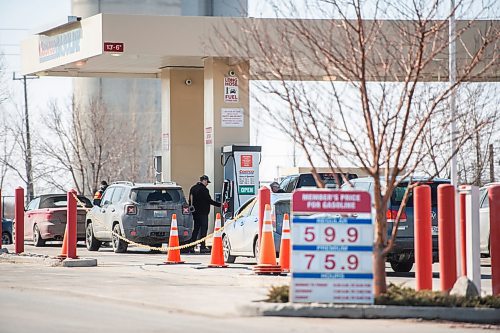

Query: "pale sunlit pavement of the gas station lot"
left=0, top=243, right=491, bottom=332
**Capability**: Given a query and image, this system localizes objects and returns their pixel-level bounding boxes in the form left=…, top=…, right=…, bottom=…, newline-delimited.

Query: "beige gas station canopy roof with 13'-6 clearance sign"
left=21, top=14, right=500, bottom=81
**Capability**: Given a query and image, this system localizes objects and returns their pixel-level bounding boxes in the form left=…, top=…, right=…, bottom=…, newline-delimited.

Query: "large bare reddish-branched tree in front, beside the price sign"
left=211, top=0, right=499, bottom=295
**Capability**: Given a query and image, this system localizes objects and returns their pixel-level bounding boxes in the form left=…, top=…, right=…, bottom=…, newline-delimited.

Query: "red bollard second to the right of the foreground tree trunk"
left=438, top=184, right=457, bottom=291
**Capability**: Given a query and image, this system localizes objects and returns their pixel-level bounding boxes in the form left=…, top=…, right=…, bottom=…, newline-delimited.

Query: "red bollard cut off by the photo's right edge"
left=488, top=185, right=500, bottom=296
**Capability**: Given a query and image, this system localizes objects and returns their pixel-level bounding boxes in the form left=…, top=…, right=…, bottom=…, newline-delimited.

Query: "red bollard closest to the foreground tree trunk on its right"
left=413, top=185, right=432, bottom=290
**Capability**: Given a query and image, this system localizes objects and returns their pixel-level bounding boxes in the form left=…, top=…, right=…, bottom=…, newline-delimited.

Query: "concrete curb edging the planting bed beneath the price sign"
left=238, top=302, right=500, bottom=324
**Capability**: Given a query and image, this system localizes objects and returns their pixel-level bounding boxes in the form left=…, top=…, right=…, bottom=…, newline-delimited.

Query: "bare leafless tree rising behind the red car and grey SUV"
left=41, top=99, right=114, bottom=195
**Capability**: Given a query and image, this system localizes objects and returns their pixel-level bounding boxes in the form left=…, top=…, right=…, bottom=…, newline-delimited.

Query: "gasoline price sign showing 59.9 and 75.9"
left=290, top=190, right=373, bottom=304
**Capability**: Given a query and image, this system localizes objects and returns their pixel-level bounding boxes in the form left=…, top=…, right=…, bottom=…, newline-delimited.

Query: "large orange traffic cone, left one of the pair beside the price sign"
left=254, top=204, right=281, bottom=274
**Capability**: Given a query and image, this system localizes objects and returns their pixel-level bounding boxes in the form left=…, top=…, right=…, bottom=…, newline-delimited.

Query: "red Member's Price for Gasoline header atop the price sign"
left=292, top=190, right=371, bottom=213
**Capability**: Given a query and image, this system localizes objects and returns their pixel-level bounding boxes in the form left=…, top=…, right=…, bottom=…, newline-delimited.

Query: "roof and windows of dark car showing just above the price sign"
left=280, top=172, right=358, bottom=193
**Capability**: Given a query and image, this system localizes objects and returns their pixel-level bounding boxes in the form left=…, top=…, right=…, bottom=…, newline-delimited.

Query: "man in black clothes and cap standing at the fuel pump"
left=189, top=175, right=221, bottom=253
